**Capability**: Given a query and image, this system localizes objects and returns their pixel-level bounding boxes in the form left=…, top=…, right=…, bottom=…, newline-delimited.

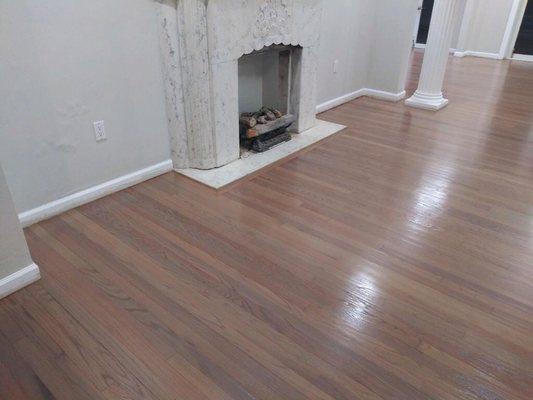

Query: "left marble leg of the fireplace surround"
left=172, top=0, right=240, bottom=169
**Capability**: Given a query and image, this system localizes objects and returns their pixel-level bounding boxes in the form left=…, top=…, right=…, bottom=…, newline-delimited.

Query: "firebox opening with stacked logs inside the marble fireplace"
left=239, top=45, right=296, bottom=155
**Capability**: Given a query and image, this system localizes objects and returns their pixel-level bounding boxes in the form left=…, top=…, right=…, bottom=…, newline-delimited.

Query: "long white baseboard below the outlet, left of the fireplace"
left=18, top=160, right=172, bottom=227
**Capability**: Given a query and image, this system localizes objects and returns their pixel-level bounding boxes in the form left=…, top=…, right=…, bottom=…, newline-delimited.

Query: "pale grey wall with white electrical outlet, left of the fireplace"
left=0, top=0, right=169, bottom=212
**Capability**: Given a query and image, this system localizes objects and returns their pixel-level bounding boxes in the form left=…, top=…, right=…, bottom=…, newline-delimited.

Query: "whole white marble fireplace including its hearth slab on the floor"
left=157, top=0, right=344, bottom=187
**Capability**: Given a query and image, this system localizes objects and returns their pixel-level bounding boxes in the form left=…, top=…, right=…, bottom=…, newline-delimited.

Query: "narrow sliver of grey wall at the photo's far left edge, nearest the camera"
left=0, top=165, right=32, bottom=279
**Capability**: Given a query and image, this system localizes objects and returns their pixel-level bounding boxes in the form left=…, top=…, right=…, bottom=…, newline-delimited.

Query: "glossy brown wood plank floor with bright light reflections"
left=0, top=54, right=533, bottom=400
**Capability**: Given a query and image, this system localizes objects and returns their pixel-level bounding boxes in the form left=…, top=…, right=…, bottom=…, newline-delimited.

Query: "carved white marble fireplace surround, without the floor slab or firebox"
left=166, top=0, right=322, bottom=169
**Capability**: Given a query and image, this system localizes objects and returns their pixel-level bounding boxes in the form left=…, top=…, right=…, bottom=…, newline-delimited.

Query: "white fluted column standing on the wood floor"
left=405, top=0, right=459, bottom=111
